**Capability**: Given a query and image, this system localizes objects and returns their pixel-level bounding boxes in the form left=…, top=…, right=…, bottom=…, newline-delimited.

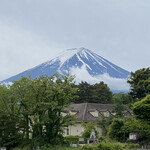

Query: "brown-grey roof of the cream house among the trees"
left=69, top=103, right=131, bottom=122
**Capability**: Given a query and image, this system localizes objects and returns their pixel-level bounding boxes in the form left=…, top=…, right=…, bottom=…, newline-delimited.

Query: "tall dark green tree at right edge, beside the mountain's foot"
left=127, top=68, right=150, bottom=99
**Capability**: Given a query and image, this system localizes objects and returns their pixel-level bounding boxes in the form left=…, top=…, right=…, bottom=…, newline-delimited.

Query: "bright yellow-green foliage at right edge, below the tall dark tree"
left=133, top=94, right=150, bottom=124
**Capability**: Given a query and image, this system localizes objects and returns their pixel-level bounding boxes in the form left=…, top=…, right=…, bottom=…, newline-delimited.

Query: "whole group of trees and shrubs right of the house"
left=108, top=68, right=150, bottom=143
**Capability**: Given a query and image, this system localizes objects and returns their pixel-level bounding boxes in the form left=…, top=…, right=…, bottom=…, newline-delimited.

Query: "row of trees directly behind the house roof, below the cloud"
left=73, top=82, right=133, bottom=105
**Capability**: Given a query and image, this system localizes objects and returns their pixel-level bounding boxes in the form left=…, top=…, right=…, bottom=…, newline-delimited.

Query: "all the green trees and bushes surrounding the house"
left=0, top=68, right=150, bottom=150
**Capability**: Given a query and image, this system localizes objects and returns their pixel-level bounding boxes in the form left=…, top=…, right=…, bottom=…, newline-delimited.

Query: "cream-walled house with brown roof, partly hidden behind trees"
left=64, top=103, right=131, bottom=136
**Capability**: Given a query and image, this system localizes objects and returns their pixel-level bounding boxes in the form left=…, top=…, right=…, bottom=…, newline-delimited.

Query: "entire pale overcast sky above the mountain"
left=0, top=0, right=150, bottom=81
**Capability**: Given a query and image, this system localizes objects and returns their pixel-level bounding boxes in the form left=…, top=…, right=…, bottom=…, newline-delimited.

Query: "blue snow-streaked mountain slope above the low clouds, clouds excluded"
left=2, top=48, right=130, bottom=89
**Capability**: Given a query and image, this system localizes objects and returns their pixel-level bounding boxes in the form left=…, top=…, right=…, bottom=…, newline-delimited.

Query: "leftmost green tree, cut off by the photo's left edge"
left=0, top=85, right=21, bottom=149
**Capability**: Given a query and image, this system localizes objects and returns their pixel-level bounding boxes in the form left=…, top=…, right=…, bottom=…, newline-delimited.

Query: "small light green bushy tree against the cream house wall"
left=82, top=122, right=98, bottom=139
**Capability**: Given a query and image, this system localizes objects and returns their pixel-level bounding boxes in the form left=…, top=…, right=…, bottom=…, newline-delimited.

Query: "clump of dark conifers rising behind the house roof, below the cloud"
left=73, top=82, right=112, bottom=104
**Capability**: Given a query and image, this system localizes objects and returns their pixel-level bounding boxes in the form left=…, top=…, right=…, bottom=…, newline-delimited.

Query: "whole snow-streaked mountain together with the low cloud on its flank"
left=1, top=47, right=130, bottom=90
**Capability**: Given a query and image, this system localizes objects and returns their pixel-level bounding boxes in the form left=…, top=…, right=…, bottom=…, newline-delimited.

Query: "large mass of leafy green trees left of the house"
left=0, top=74, right=77, bottom=149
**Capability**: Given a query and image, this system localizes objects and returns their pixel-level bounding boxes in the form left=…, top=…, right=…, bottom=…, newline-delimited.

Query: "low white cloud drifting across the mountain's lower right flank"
left=70, top=65, right=129, bottom=91
